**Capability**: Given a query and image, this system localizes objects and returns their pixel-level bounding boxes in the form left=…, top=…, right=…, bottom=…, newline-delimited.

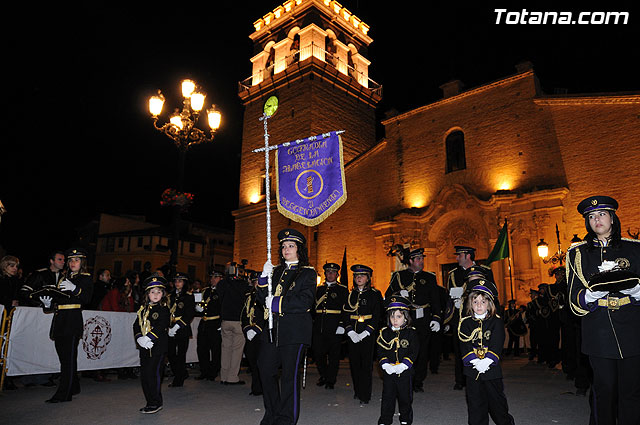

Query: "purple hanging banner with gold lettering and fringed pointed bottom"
left=276, top=131, right=347, bottom=226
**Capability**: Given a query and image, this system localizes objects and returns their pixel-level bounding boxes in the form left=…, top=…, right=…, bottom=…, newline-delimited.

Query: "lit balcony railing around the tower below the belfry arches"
left=238, top=43, right=382, bottom=96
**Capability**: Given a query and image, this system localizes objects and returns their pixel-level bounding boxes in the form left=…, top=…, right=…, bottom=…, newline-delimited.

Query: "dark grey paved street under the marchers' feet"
left=0, top=357, right=589, bottom=425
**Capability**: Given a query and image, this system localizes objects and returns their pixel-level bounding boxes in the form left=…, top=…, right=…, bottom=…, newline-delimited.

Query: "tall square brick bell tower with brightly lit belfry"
left=233, top=0, right=382, bottom=268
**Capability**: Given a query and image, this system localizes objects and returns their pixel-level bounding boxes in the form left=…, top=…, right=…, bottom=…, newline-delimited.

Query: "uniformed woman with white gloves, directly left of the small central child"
left=343, top=264, right=383, bottom=404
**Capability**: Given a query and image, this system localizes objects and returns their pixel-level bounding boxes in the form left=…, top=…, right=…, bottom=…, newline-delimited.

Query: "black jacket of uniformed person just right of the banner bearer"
left=313, top=282, right=349, bottom=335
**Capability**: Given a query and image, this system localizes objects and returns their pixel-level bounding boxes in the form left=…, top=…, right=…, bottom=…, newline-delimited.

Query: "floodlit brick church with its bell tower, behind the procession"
left=234, top=0, right=640, bottom=302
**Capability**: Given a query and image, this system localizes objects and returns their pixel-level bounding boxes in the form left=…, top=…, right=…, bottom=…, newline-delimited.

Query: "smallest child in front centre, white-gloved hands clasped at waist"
left=377, top=296, right=420, bottom=425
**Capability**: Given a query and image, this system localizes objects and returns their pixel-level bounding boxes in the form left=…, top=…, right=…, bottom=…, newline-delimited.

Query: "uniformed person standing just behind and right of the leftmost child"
left=168, top=273, right=196, bottom=387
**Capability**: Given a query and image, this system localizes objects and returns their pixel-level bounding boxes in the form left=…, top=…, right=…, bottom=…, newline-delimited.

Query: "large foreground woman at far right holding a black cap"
left=567, top=196, right=640, bottom=425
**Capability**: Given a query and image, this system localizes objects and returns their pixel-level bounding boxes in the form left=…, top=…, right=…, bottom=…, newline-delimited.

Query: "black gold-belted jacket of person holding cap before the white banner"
left=44, top=273, right=93, bottom=339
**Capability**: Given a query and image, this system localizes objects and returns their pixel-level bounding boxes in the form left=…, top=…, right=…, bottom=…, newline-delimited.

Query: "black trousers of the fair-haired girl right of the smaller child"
left=466, top=376, right=515, bottom=425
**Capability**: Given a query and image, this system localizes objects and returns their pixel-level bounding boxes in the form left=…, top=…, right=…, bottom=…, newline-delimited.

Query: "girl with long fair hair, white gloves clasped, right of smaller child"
left=458, top=279, right=515, bottom=425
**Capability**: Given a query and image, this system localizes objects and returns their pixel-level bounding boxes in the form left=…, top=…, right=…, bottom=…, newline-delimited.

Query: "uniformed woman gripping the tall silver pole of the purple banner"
left=257, top=229, right=317, bottom=425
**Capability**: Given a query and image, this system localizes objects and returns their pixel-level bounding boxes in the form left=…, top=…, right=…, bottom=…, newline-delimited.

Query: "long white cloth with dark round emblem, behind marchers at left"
left=7, top=307, right=200, bottom=376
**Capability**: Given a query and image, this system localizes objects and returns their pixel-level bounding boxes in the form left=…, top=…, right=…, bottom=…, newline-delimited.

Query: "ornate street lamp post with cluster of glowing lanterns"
left=149, top=80, right=222, bottom=274
